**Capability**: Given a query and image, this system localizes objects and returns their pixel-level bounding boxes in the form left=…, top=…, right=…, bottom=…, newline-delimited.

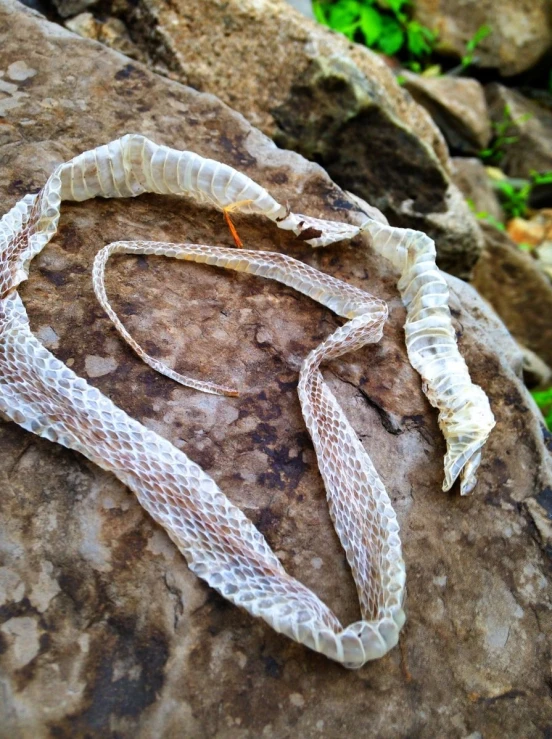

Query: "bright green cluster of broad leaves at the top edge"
left=313, top=0, right=437, bottom=66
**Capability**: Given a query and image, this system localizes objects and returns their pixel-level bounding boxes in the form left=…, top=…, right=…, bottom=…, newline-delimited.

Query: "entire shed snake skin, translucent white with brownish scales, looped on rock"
left=0, top=135, right=494, bottom=668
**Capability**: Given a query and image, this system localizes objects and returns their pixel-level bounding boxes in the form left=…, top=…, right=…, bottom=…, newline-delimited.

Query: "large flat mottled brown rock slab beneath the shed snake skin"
left=0, top=0, right=552, bottom=739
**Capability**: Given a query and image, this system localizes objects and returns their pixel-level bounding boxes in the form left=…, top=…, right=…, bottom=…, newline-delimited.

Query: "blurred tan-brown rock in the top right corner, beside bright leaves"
left=412, top=0, right=552, bottom=76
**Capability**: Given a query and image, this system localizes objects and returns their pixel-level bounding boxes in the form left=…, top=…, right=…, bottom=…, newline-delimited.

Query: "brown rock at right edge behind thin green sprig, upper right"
left=485, top=84, right=552, bottom=177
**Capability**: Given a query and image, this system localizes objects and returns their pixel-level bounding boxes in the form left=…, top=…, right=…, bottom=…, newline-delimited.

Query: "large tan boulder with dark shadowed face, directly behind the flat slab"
left=111, top=0, right=483, bottom=276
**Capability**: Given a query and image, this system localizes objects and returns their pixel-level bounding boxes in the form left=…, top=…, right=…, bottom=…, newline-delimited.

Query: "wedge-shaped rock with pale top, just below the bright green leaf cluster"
left=403, top=71, right=491, bottom=154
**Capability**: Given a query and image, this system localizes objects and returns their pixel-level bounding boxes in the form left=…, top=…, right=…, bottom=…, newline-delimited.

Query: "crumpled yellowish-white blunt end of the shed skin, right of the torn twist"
left=363, top=220, right=495, bottom=495
